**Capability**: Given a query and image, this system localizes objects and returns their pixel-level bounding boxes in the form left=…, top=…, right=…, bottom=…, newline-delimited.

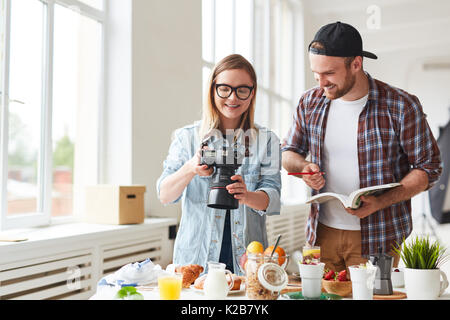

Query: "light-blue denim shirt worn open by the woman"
left=156, top=122, right=281, bottom=273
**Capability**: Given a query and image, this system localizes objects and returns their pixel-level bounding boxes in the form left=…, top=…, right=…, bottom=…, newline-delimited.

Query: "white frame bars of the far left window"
left=0, top=0, right=107, bottom=231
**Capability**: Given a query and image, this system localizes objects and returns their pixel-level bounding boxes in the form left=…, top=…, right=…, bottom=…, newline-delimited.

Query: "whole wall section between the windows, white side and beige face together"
left=102, top=0, right=202, bottom=217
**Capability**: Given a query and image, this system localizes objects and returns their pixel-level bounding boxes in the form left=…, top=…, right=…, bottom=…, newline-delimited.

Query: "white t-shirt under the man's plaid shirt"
left=319, top=95, right=369, bottom=230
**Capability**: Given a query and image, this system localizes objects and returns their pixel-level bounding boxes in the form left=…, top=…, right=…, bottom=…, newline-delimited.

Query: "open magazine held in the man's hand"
left=306, top=182, right=401, bottom=209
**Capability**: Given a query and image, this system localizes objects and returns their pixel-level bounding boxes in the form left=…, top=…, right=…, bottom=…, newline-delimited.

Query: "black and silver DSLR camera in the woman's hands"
left=200, top=144, right=248, bottom=210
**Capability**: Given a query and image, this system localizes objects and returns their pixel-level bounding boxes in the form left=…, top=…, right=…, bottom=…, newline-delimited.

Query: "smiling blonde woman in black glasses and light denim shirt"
left=157, top=54, right=281, bottom=273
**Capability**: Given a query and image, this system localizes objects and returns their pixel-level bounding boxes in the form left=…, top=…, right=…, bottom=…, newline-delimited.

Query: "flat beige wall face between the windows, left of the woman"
left=132, top=0, right=202, bottom=220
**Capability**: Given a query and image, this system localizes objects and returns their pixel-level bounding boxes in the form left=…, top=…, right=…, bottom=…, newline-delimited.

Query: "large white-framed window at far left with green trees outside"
left=0, top=0, right=104, bottom=229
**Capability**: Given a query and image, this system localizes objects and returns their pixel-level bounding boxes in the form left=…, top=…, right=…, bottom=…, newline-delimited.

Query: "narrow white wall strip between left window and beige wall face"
left=100, top=0, right=132, bottom=185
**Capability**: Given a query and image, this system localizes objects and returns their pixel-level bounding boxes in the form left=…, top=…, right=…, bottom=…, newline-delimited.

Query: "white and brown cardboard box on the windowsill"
left=85, top=185, right=145, bottom=224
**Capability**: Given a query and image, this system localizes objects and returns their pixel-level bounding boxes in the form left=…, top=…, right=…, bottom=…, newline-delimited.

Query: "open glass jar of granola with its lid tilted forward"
left=245, top=253, right=288, bottom=300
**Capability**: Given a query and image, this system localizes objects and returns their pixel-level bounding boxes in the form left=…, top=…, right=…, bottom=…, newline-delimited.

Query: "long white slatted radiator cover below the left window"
left=0, top=218, right=176, bottom=300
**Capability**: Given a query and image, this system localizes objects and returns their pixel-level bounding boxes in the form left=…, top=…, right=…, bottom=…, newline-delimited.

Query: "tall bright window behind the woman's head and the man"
left=202, top=0, right=308, bottom=204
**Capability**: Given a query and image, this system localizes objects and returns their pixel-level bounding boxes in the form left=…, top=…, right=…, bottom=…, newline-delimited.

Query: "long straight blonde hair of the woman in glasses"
left=200, top=54, right=257, bottom=140
